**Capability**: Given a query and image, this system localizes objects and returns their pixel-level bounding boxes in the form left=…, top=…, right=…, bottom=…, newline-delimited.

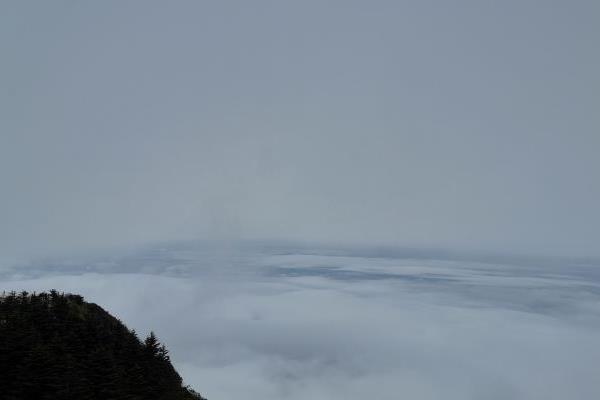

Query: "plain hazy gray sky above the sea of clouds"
left=0, top=0, right=600, bottom=257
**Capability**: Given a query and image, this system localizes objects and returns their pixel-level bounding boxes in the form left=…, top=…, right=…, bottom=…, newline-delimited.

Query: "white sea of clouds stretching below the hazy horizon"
left=0, top=244, right=600, bottom=400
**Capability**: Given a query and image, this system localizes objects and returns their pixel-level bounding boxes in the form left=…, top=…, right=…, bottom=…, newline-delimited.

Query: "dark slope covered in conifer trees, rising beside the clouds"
left=0, top=290, right=203, bottom=400
